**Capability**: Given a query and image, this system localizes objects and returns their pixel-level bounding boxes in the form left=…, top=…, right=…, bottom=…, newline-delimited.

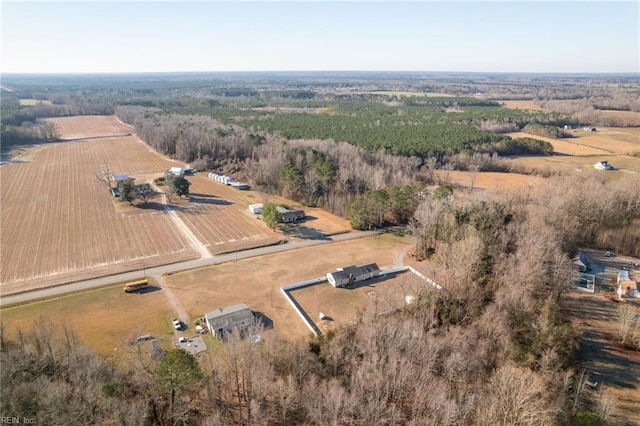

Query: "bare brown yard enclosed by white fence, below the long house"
left=290, top=271, right=429, bottom=333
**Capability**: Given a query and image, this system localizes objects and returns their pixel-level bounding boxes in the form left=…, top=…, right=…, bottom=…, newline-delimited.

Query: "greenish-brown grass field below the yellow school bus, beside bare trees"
left=0, top=285, right=175, bottom=357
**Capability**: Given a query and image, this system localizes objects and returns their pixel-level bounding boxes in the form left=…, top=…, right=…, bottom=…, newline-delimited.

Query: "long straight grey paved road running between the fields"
left=0, top=231, right=380, bottom=307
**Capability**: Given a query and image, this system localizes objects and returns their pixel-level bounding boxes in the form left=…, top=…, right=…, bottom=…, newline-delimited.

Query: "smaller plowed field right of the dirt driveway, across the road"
left=172, top=176, right=280, bottom=254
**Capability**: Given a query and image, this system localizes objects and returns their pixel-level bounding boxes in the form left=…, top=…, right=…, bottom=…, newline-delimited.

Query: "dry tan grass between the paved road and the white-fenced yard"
left=164, top=235, right=411, bottom=339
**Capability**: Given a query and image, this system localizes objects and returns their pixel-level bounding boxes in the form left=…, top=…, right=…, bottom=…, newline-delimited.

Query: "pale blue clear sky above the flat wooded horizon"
left=0, top=0, right=640, bottom=73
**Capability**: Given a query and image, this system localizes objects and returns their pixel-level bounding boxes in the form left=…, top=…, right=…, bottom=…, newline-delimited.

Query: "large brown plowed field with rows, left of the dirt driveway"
left=0, top=116, right=197, bottom=294
